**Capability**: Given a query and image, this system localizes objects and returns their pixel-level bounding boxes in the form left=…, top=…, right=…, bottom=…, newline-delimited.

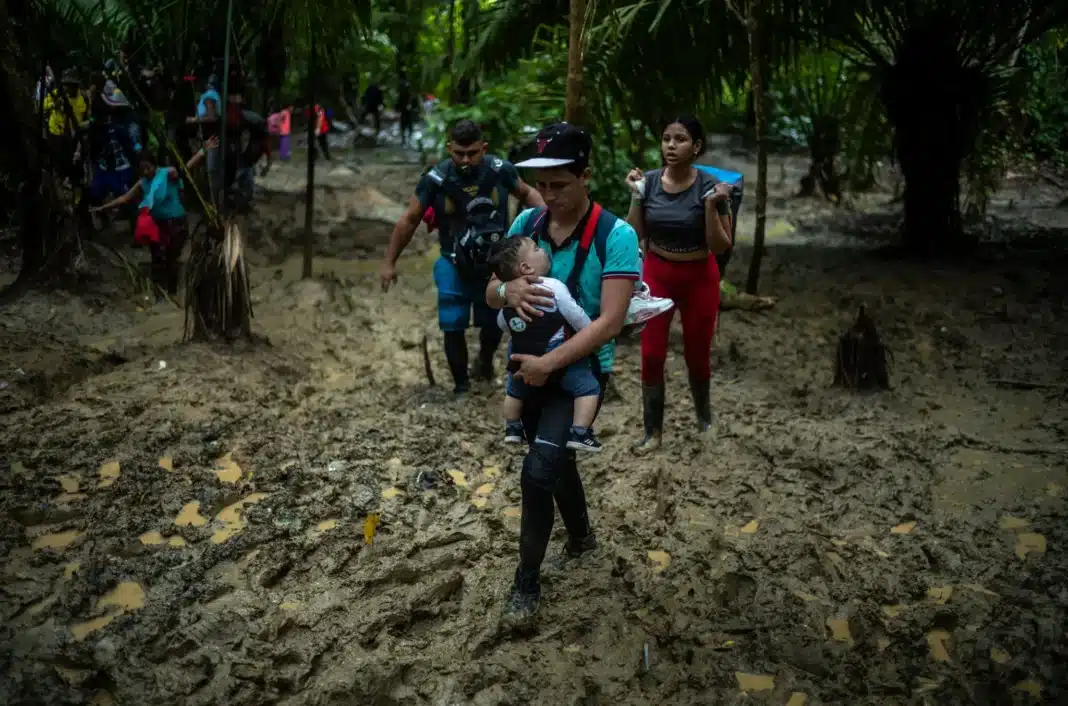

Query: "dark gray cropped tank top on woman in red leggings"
left=642, top=169, right=728, bottom=253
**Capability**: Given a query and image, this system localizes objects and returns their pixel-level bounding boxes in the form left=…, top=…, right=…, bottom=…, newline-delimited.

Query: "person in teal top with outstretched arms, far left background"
left=92, top=137, right=219, bottom=297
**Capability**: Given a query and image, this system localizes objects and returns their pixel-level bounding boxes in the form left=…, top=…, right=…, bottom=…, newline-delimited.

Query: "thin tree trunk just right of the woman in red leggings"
left=745, top=0, right=768, bottom=295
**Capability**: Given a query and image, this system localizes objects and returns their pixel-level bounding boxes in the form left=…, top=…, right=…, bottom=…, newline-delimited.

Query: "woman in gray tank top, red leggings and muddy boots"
left=627, top=112, right=731, bottom=451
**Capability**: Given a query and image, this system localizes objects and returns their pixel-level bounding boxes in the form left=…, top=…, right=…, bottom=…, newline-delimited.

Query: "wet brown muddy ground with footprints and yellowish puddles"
left=0, top=139, right=1068, bottom=706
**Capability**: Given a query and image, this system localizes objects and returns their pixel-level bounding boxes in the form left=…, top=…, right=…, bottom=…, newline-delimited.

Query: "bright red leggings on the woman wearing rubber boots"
left=642, top=252, right=720, bottom=385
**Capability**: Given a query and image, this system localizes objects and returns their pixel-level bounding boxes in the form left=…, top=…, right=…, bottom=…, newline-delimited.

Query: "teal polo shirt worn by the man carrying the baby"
left=508, top=208, right=642, bottom=373
